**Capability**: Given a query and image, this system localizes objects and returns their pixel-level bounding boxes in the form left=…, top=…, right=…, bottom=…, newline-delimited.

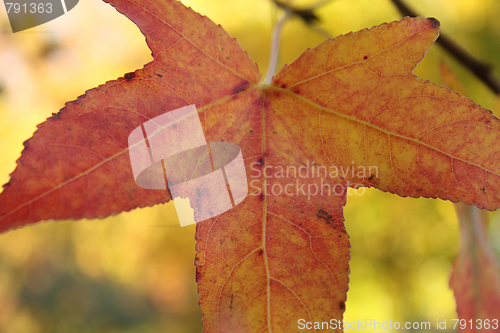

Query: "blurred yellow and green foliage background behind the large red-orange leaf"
left=0, top=0, right=500, bottom=333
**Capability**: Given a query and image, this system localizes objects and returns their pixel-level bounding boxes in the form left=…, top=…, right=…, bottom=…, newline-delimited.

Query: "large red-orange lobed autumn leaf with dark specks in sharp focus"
left=0, top=0, right=500, bottom=332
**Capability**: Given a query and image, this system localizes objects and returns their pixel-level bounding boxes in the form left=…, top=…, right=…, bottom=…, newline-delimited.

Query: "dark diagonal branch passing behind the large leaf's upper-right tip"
left=392, top=0, right=500, bottom=95
